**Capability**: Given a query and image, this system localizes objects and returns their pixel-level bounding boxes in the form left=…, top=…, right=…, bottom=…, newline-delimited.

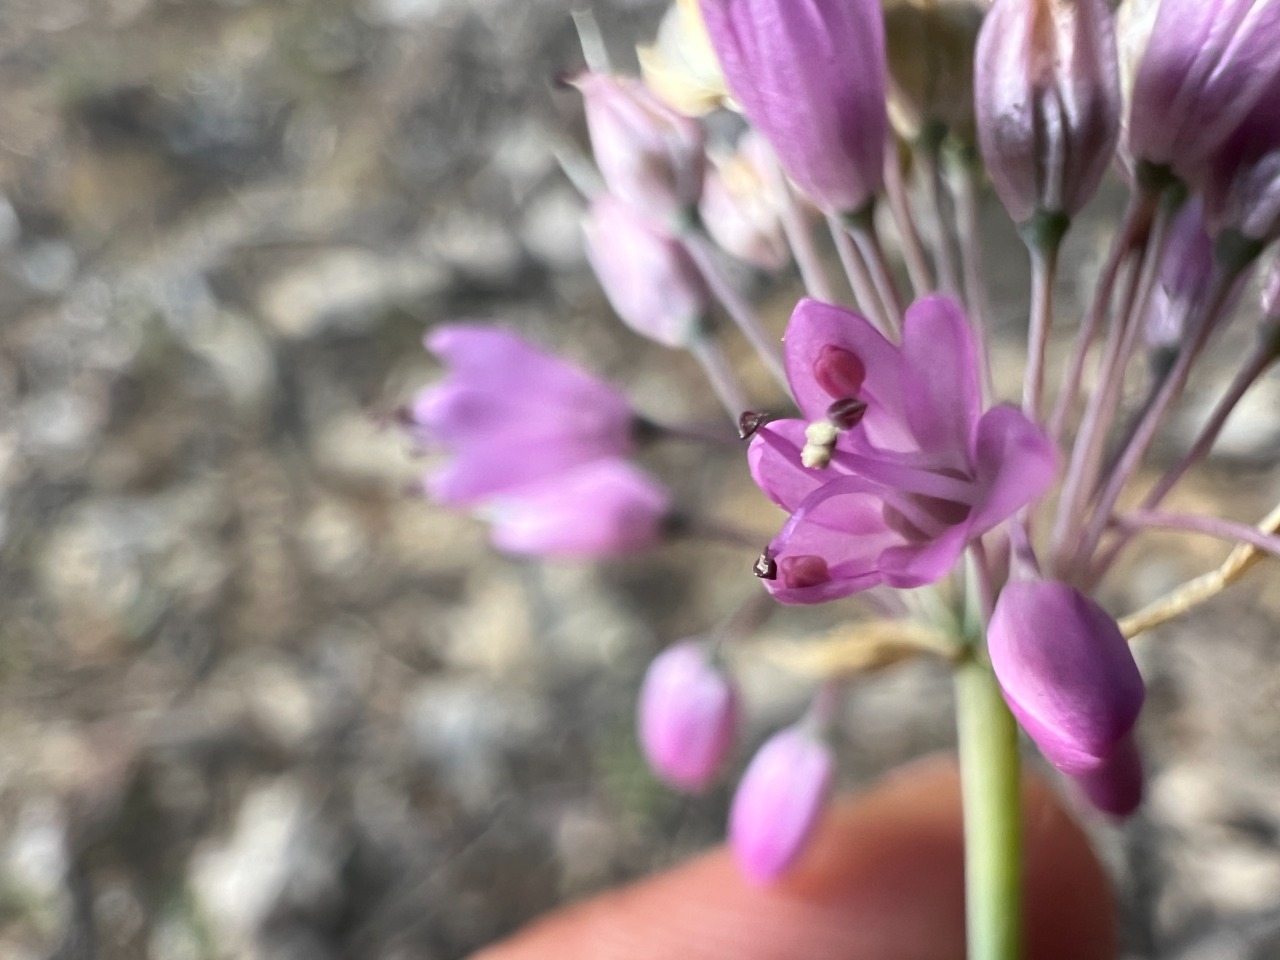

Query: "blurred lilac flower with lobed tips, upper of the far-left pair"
left=406, top=324, right=634, bottom=507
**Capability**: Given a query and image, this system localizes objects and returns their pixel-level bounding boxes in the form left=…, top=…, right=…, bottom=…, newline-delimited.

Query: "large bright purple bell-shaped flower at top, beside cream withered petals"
left=701, top=0, right=888, bottom=212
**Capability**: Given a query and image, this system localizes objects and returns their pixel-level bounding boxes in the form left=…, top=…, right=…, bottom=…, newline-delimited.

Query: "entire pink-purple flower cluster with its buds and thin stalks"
left=394, top=0, right=1280, bottom=901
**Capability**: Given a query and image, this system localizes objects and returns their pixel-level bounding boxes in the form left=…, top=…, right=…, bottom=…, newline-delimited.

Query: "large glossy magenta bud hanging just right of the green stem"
left=987, top=581, right=1146, bottom=776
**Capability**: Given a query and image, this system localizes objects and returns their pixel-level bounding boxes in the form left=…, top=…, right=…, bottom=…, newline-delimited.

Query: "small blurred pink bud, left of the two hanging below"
left=639, top=640, right=739, bottom=794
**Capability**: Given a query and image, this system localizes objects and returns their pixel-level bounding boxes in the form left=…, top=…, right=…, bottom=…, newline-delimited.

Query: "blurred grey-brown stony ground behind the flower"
left=0, top=0, right=1280, bottom=960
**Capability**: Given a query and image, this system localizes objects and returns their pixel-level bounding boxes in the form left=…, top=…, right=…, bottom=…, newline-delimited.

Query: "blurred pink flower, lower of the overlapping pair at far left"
left=480, top=460, right=671, bottom=558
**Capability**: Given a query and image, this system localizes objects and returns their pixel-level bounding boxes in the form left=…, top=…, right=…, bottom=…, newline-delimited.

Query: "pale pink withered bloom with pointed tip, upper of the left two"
left=573, top=73, right=705, bottom=228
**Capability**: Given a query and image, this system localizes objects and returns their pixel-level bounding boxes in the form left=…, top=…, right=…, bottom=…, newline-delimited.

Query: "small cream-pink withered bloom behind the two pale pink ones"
left=698, top=131, right=791, bottom=270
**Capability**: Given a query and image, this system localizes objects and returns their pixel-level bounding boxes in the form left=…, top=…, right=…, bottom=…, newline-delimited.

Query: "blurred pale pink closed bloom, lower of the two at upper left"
left=582, top=193, right=710, bottom=347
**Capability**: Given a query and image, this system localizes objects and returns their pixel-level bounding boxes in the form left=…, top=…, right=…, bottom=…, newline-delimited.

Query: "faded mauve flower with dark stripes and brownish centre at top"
left=974, top=0, right=1120, bottom=224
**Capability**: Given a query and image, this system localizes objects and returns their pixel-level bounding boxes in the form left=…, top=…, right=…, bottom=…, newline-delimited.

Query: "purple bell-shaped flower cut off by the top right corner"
left=1129, top=0, right=1280, bottom=178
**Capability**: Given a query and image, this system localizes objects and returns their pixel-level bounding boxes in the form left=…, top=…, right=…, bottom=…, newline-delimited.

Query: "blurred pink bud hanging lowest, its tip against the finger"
left=728, top=724, right=836, bottom=882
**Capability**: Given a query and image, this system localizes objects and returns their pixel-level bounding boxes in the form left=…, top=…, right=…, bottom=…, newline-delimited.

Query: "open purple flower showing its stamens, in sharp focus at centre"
left=749, top=297, right=1057, bottom=603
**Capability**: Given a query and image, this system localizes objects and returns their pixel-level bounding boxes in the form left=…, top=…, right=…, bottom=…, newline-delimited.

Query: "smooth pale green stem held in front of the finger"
left=955, top=655, right=1023, bottom=960
